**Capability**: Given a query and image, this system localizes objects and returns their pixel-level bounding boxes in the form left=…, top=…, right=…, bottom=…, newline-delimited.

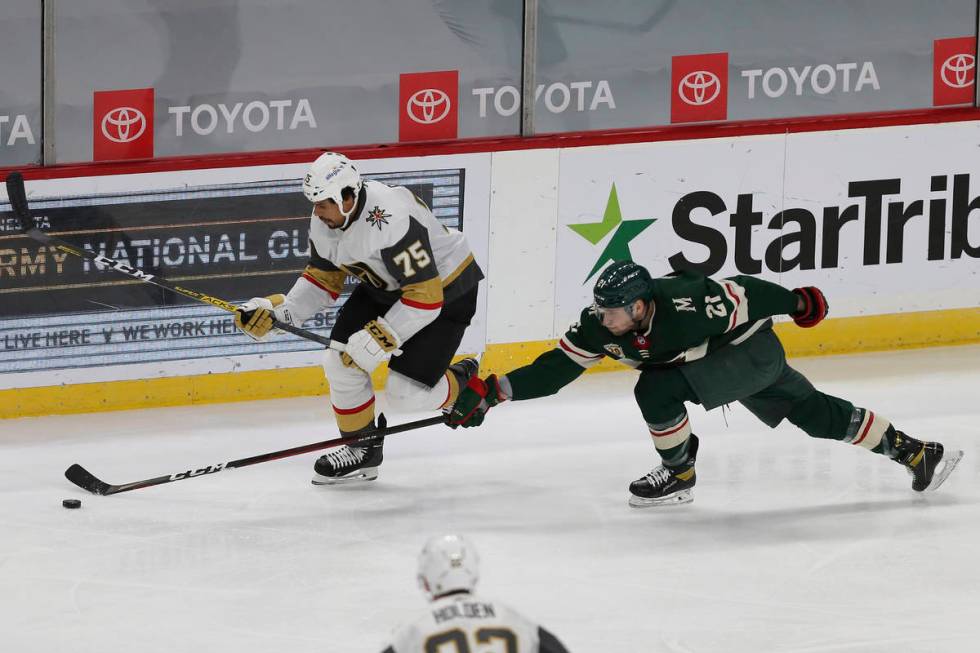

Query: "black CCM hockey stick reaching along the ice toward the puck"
left=65, top=413, right=446, bottom=496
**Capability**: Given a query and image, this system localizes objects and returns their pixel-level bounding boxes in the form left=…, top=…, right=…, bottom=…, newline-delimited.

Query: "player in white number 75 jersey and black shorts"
left=235, top=152, right=483, bottom=485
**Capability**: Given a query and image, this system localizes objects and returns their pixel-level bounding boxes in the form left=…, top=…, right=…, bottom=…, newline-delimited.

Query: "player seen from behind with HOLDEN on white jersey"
left=383, top=535, right=567, bottom=653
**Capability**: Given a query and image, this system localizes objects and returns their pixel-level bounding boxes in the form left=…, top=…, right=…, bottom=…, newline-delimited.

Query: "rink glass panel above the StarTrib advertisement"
left=534, top=0, right=977, bottom=133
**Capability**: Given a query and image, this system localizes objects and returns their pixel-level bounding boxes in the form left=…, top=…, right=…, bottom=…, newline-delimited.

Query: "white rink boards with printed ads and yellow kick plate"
left=0, top=114, right=980, bottom=417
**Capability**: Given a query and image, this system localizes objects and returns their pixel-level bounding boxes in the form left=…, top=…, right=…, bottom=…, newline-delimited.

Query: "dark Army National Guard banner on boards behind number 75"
left=0, top=157, right=487, bottom=386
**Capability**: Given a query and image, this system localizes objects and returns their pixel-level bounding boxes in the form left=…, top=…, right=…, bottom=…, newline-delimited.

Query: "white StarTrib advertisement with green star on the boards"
left=556, top=123, right=980, bottom=329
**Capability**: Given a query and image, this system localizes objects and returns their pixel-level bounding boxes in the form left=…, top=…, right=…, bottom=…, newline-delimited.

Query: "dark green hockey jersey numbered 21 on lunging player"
left=507, top=271, right=798, bottom=400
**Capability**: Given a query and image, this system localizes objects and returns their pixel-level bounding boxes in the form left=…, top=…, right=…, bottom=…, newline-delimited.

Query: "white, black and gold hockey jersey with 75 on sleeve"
left=303, top=180, right=483, bottom=340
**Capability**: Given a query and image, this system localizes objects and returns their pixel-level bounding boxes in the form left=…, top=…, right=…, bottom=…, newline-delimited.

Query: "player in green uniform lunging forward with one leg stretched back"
left=450, top=261, right=963, bottom=508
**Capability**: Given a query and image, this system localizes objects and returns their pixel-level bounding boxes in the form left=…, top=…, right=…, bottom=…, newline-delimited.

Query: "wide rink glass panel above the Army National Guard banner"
left=50, top=0, right=523, bottom=162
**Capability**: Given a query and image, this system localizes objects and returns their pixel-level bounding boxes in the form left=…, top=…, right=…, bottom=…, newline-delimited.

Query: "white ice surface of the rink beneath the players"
left=0, top=346, right=980, bottom=653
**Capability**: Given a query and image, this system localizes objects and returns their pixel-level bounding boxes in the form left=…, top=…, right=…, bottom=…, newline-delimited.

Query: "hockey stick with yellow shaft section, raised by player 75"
left=1, top=172, right=334, bottom=351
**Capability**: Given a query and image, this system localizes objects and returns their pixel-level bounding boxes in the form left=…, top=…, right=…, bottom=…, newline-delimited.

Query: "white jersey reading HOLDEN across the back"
left=384, top=592, right=567, bottom=653
